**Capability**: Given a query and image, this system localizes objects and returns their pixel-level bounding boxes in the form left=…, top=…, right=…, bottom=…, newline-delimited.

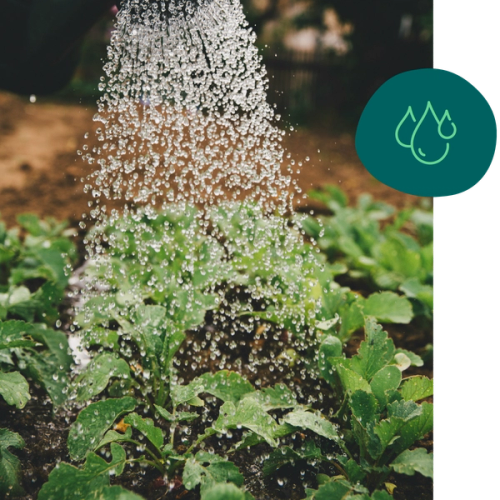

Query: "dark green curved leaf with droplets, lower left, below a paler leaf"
left=68, top=397, right=137, bottom=460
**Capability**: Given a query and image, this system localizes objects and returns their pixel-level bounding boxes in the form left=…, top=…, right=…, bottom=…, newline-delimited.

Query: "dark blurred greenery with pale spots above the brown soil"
left=57, top=0, right=434, bottom=130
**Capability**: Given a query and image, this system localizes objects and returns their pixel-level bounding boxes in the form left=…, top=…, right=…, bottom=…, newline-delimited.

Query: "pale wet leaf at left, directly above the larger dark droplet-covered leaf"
left=75, top=352, right=130, bottom=401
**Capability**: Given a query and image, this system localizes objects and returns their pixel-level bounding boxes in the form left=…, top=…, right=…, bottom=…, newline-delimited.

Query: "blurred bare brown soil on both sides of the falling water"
left=0, top=92, right=430, bottom=226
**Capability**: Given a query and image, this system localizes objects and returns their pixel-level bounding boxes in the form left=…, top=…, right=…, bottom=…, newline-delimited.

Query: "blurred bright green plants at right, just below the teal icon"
left=304, top=186, right=434, bottom=318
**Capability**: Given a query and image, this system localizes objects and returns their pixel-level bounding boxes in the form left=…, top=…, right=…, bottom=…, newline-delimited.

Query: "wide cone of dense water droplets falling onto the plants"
left=77, top=0, right=324, bottom=398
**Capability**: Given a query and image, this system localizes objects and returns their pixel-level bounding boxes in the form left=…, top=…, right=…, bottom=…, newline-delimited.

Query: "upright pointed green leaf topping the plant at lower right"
left=351, top=317, right=395, bottom=381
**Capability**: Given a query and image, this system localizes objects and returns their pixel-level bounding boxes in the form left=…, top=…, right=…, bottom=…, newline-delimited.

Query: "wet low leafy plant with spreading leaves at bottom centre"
left=39, top=376, right=308, bottom=500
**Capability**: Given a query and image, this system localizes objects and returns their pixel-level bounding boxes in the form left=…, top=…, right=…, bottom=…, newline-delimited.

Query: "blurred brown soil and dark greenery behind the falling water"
left=0, top=0, right=434, bottom=226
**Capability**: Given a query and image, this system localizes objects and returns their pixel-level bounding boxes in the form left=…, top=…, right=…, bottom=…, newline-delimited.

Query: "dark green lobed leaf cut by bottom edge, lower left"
left=38, top=443, right=129, bottom=500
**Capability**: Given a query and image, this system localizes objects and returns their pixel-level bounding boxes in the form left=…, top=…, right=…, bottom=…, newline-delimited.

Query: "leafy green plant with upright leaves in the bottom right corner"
left=264, top=317, right=435, bottom=500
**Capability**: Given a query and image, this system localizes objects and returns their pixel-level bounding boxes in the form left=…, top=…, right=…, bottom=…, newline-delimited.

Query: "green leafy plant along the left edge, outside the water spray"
left=0, top=214, right=76, bottom=495
